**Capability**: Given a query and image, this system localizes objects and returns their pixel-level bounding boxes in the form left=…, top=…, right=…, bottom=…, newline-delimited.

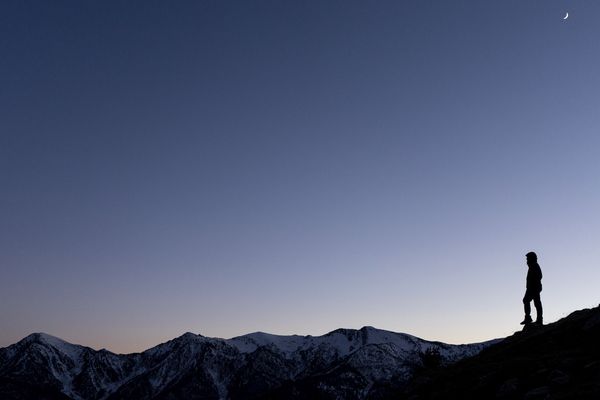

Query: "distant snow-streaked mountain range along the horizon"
left=0, top=327, right=494, bottom=400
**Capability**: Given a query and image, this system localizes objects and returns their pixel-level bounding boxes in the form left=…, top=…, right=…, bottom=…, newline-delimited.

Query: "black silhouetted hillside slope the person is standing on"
left=398, top=307, right=600, bottom=399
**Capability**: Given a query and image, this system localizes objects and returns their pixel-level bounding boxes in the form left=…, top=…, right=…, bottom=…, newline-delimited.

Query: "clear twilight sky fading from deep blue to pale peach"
left=0, top=0, right=600, bottom=352
